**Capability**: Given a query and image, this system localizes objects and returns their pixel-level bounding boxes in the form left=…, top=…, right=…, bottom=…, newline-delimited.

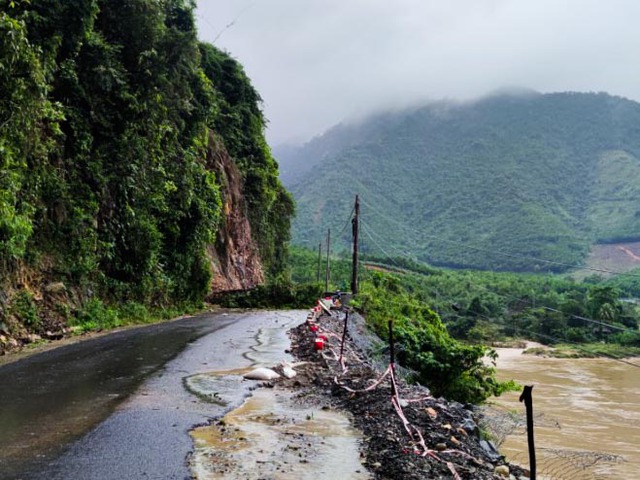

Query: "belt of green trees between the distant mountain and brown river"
left=291, top=247, right=640, bottom=368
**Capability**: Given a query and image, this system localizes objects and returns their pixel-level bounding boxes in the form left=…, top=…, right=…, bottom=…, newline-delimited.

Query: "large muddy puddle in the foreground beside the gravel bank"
left=191, top=388, right=371, bottom=480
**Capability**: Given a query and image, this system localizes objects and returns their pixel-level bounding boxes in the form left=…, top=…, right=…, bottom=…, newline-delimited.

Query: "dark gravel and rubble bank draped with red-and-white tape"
left=277, top=312, right=527, bottom=480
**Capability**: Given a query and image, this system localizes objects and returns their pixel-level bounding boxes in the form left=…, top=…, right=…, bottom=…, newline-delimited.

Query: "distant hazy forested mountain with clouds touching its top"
left=283, top=92, right=640, bottom=271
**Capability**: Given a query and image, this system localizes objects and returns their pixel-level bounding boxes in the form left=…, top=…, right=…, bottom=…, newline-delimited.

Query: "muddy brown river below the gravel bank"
left=492, top=349, right=640, bottom=480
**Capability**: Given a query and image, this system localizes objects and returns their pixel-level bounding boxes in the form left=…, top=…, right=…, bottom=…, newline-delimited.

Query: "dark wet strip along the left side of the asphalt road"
left=0, top=315, right=238, bottom=478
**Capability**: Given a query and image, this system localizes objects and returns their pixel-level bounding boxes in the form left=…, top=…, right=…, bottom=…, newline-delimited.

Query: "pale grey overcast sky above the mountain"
left=197, top=0, right=640, bottom=145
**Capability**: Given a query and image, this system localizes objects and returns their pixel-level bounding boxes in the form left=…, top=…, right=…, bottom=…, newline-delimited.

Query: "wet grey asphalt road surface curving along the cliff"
left=0, top=312, right=300, bottom=480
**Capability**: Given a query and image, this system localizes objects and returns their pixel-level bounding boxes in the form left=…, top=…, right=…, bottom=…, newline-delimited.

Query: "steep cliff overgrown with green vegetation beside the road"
left=0, top=0, right=293, bottom=344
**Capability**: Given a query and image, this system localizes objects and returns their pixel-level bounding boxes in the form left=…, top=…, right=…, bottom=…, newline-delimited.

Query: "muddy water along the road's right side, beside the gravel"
left=184, top=317, right=371, bottom=480
